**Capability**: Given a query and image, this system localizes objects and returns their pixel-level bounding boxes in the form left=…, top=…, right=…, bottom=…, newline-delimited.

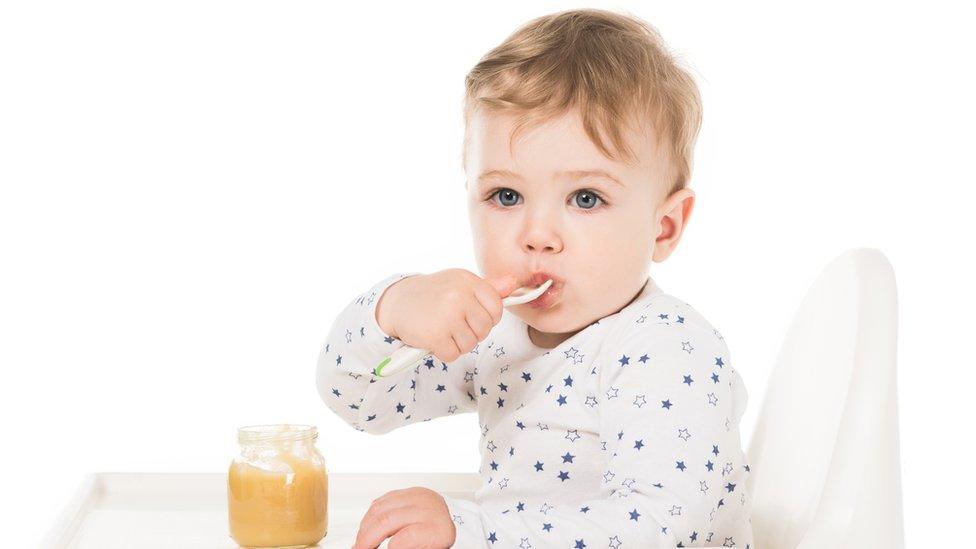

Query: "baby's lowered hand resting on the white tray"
left=353, top=487, right=457, bottom=549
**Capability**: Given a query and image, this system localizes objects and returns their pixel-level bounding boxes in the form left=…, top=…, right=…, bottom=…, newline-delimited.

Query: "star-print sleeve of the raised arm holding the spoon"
left=316, top=273, right=477, bottom=434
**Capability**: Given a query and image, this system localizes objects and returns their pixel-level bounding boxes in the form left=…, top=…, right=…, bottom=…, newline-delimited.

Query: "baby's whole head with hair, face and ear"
left=463, top=9, right=701, bottom=337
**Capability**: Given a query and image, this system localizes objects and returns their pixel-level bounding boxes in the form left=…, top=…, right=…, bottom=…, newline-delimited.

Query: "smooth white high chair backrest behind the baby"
left=747, top=248, right=905, bottom=549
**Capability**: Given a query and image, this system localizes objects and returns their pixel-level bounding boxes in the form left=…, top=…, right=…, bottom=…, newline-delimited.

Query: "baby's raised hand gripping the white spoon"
left=376, top=269, right=518, bottom=362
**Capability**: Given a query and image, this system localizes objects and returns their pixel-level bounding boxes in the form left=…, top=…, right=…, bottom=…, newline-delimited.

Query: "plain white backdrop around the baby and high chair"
left=0, top=0, right=976, bottom=547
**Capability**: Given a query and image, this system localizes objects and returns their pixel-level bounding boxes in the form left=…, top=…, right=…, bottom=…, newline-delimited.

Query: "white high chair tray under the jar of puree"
left=42, top=473, right=481, bottom=549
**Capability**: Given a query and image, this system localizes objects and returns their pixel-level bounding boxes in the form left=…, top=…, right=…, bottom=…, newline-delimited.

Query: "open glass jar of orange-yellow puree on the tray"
left=227, top=425, right=329, bottom=548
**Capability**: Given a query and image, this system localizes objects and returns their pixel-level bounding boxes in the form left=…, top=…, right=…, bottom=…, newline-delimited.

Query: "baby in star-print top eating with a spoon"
left=317, top=9, right=752, bottom=549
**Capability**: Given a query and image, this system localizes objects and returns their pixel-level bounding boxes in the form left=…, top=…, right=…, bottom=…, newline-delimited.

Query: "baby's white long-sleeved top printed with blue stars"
left=317, top=273, right=753, bottom=549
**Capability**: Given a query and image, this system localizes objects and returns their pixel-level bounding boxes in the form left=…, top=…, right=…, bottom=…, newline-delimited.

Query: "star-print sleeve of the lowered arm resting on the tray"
left=446, top=305, right=751, bottom=549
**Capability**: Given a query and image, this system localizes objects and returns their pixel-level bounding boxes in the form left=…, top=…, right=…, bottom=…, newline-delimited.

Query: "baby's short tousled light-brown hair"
left=462, top=9, right=702, bottom=197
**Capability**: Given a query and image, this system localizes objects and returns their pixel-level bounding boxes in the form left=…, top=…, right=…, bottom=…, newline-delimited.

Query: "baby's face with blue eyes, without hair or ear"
left=465, top=110, right=680, bottom=337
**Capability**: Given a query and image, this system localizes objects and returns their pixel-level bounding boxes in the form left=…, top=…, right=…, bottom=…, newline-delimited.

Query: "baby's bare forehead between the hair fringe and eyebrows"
left=465, top=109, right=658, bottom=180
